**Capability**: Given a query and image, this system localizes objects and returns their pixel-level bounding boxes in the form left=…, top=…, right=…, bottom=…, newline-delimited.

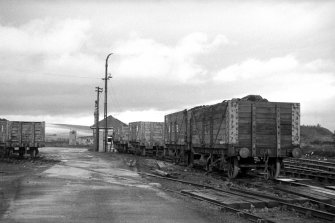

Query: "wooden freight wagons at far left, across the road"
left=0, top=119, right=45, bottom=157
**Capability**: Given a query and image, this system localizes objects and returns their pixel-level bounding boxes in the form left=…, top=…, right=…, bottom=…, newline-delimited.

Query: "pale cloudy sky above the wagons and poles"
left=0, top=0, right=335, bottom=131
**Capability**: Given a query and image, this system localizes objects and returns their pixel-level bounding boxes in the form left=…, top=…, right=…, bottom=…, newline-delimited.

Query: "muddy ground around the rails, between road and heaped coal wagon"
left=117, top=154, right=327, bottom=223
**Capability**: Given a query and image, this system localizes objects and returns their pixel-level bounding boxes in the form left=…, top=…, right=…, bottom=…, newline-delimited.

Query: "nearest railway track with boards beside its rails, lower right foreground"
left=142, top=173, right=335, bottom=222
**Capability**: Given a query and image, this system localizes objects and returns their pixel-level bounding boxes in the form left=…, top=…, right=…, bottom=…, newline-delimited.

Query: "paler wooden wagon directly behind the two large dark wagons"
left=129, top=122, right=164, bottom=156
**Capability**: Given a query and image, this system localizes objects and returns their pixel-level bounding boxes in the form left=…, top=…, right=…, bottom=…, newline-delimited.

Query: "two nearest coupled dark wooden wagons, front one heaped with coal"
left=164, top=96, right=301, bottom=178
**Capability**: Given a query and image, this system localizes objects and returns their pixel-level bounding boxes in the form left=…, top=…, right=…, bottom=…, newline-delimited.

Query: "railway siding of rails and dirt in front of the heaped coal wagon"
left=129, top=155, right=335, bottom=222
